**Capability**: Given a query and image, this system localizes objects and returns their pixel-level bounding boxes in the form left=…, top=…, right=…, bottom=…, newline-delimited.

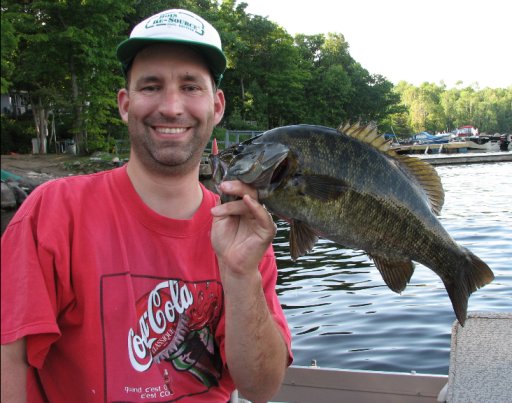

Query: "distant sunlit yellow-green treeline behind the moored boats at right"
left=384, top=81, right=512, bottom=134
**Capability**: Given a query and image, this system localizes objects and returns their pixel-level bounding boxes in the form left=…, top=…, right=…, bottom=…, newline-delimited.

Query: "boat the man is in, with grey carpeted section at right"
left=230, top=312, right=512, bottom=403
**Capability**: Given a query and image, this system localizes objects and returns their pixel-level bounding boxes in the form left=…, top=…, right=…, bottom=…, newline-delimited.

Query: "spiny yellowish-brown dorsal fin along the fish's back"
left=338, top=120, right=444, bottom=215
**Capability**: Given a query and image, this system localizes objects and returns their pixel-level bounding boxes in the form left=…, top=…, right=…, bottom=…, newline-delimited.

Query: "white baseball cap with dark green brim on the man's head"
left=117, top=9, right=227, bottom=85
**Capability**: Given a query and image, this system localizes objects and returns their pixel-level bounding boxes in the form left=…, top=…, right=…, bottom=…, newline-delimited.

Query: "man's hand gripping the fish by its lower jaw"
left=212, top=181, right=276, bottom=276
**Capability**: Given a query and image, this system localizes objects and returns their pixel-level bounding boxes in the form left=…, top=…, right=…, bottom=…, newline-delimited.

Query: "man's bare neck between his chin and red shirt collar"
left=126, top=158, right=203, bottom=220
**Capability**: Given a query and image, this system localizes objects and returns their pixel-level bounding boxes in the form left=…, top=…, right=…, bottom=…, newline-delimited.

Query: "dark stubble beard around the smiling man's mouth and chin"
left=128, top=116, right=213, bottom=176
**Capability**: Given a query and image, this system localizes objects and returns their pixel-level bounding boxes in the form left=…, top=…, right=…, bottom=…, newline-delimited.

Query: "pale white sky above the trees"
left=237, top=0, right=512, bottom=89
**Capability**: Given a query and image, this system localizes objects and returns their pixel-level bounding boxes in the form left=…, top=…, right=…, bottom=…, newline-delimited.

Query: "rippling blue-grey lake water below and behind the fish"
left=274, top=162, right=512, bottom=375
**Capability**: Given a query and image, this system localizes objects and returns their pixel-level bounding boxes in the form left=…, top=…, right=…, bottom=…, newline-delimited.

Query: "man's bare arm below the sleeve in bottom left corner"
left=1, top=337, right=28, bottom=403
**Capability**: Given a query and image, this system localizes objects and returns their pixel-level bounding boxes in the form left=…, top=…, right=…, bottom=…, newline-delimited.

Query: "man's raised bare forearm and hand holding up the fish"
left=212, top=181, right=289, bottom=403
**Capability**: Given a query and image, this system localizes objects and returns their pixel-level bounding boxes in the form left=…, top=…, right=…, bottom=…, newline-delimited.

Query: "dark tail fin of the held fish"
left=444, top=248, right=494, bottom=326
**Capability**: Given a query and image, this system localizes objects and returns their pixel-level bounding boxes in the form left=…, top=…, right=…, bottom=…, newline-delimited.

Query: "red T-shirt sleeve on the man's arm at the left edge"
left=1, top=186, right=60, bottom=368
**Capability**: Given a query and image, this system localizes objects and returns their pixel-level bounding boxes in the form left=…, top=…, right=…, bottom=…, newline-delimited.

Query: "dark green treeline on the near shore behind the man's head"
left=2, top=0, right=400, bottom=155
